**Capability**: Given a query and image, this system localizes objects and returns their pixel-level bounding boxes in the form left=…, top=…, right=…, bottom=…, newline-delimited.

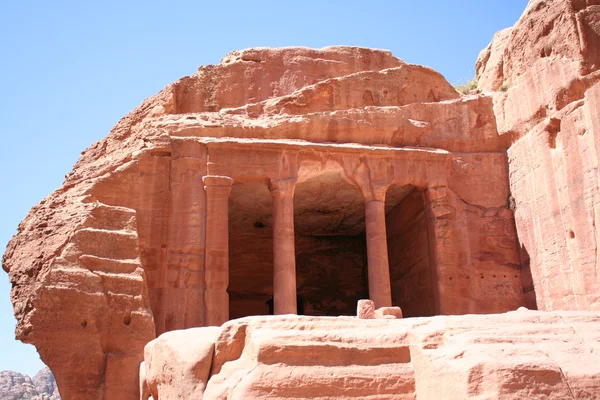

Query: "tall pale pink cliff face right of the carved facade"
left=477, top=0, right=600, bottom=310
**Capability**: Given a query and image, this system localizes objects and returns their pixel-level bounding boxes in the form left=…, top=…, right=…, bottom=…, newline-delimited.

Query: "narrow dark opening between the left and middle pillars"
left=227, top=180, right=273, bottom=319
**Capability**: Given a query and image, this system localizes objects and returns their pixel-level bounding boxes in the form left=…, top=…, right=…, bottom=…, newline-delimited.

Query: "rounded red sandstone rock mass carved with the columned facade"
left=3, top=42, right=524, bottom=399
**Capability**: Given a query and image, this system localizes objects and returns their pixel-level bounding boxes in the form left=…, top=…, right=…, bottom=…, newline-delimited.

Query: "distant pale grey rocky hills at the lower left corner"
left=0, top=367, right=61, bottom=400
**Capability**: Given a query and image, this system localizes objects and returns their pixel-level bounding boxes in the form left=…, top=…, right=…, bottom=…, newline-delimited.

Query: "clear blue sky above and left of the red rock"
left=0, top=0, right=527, bottom=374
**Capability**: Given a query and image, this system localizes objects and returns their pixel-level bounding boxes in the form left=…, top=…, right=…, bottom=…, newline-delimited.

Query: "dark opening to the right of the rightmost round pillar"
left=386, top=185, right=437, bottom=317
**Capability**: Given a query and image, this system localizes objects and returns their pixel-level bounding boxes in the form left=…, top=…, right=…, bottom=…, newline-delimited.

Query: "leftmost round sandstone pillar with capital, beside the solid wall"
left=202, top=175, right=233, bottom=326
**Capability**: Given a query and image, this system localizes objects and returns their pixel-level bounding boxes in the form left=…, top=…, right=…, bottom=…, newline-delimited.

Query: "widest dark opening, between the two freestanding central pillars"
left=294, top=173, right=368, bottom=316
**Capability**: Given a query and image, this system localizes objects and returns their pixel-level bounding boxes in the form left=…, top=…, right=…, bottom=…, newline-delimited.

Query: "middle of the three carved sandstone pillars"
left=271, top=178, right=298, bottom=315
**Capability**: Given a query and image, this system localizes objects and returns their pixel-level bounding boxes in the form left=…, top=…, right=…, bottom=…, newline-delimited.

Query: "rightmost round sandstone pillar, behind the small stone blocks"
left=365, top=192, right=392, bottom=308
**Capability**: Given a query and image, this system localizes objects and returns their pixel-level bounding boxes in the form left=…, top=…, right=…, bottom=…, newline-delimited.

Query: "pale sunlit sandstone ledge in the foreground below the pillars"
left=141, top=309, right=600, bottom=400
